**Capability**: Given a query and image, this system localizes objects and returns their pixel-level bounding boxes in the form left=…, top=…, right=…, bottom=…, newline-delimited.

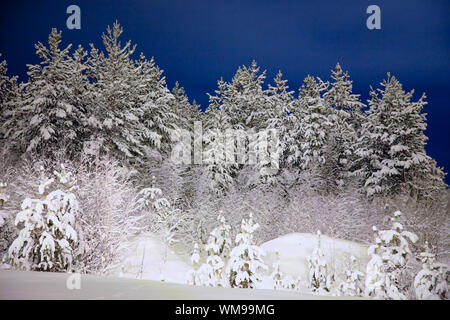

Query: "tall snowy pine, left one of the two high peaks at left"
left=5, top=29, right=85, bottom=157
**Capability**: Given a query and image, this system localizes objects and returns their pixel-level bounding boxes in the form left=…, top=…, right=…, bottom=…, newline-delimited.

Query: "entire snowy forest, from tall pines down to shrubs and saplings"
left=0, top=22, right=450, bottom=299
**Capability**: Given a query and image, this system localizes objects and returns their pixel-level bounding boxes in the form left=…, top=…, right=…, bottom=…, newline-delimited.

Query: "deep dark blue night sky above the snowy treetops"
left=0, top=0, right=450, bottom=183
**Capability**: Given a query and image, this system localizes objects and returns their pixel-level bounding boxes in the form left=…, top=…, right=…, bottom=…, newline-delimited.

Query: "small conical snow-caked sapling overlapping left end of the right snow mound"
left=227, top=213, right=268, bottom=288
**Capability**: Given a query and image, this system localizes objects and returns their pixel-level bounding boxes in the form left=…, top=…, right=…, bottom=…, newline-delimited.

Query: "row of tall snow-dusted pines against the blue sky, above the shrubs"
left=0, top=22, right=448, bottom=254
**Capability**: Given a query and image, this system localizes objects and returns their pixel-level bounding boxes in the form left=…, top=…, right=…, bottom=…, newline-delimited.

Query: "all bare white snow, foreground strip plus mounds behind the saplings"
left=0, top=233, right=368, bottom=300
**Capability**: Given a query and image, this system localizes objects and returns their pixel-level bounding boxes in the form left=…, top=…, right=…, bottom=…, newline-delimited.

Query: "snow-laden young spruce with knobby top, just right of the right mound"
left=365, top=211, right=418, bottom=300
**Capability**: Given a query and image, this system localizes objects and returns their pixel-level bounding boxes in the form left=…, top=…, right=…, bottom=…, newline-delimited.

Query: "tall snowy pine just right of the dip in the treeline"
left=207, top=61, right=275, bottom=190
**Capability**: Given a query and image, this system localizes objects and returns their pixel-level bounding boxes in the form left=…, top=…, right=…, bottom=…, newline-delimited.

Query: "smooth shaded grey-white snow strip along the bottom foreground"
left=0, top=270, right=356, bottom=300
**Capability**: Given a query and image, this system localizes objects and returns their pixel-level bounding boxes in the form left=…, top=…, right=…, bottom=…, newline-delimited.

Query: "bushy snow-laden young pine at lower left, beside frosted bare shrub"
left=8, top=166, right=79, bottom=271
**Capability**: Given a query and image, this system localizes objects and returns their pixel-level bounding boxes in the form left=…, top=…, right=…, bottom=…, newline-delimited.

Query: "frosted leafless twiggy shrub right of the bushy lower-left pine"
left=77, top=158, right=140, bottom=274
